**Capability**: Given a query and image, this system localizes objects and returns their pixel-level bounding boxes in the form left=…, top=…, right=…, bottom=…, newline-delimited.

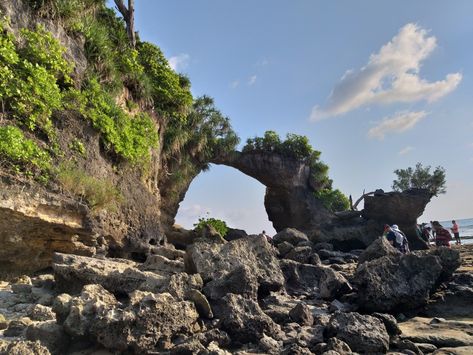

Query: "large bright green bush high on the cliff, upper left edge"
left=0, top=22, right=72, bottom=140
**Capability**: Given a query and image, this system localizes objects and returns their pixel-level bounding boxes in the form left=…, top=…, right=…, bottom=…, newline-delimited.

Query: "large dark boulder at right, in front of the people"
left=353, top=254, right=458, bottom=312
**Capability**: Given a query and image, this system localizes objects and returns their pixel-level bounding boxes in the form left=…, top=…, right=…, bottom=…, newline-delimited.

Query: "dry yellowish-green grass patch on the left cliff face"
left=57, top=163, right=123, bottom=211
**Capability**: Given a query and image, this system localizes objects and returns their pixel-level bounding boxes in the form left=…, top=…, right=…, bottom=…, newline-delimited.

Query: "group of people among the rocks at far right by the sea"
left=383, top=220, right=461, bottom=254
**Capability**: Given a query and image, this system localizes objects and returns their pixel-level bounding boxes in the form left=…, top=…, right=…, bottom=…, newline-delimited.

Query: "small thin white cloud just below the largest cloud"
left=368, top=111, right=427, bottom=140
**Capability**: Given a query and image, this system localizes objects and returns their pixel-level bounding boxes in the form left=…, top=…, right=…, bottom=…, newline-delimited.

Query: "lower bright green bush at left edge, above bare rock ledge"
left=0, top=126, right=51, bottom=179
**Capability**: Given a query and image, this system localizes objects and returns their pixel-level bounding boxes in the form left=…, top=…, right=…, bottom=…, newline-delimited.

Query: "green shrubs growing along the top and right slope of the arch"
left=243, top=131, right=350, bottom=212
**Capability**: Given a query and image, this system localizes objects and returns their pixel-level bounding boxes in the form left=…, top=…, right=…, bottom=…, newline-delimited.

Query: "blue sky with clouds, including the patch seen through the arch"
left=117, top=0, right=473, bottom=233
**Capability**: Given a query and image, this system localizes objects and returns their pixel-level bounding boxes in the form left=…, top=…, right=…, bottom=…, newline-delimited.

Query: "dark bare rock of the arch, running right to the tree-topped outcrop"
left=167, top=151, right=431, bottom=250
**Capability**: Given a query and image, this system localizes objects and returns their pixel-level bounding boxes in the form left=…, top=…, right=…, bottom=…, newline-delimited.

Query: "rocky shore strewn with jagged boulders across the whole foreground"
left=0, top=229, right=473, bottom=355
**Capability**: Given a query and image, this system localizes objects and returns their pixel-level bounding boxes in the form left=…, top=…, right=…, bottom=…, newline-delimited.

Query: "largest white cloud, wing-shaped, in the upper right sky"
left=310, top=23, right=462, bottom=121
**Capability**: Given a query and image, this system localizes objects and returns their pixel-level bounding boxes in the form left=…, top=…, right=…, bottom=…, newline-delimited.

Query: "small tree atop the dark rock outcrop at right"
left=392, top=163, right=447, bottom=196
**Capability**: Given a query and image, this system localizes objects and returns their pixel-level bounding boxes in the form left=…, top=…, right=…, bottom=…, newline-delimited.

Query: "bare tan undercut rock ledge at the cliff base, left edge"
left=0, top=185, right=96, bottom=274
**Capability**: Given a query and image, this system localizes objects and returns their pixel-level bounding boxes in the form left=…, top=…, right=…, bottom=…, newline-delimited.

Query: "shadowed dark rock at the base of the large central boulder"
left=203, top=265, right=258, bottom=301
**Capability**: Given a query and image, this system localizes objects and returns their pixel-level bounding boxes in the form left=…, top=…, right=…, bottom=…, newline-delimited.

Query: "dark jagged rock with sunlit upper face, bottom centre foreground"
left=214, top=293, right=281, bottom=343
